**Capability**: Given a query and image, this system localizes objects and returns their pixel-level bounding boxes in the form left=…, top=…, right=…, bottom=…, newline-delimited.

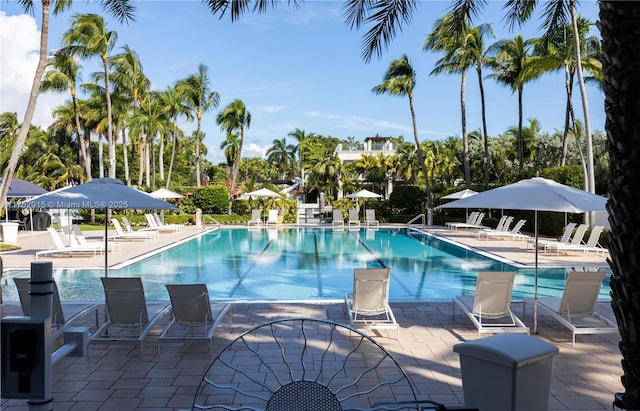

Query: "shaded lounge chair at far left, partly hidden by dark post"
left=13, top=277, right=98, bottom=342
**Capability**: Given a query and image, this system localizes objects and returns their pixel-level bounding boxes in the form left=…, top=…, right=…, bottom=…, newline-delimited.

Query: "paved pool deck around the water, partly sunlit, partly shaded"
left=0, top=227, right=623, bottom=411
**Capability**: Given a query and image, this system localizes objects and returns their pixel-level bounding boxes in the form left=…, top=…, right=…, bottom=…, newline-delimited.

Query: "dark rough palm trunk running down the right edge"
left=599, top=1, right=640, bottom=410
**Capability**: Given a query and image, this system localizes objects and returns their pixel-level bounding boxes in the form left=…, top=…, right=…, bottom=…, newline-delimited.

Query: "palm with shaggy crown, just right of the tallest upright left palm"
left=109, top=45, right=151, bottom=185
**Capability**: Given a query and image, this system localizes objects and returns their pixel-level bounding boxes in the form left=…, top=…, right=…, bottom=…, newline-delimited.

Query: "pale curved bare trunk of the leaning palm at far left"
left=0, top=0, right=51, bottom=204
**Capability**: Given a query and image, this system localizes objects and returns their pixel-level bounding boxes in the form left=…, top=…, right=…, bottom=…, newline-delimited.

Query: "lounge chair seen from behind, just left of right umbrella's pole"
left=452, top=271, right=529, bottom=336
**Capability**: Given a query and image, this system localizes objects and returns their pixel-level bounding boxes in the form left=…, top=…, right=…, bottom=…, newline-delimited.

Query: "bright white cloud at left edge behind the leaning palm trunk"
left=0, top=11, right=67, bottom=128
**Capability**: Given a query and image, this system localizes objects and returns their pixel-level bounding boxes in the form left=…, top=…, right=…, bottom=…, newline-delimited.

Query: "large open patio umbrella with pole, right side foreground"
left=437, top=177, right=607, bottom=333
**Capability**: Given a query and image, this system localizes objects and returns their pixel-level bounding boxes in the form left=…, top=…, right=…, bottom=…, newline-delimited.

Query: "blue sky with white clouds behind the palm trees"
left=0, top=0, right=605, bottom=163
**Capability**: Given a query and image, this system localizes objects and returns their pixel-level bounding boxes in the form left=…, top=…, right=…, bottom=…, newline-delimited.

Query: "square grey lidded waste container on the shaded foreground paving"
left=453, top=334, right=559, bottom=411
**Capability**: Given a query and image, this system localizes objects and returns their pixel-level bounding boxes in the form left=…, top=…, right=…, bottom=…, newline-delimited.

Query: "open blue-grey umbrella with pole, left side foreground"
left=16, top=178, right=178, bottom=277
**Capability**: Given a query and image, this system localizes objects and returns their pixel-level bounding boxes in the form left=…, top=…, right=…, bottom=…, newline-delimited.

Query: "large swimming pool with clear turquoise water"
left=3, top=227, right=609, bottom=301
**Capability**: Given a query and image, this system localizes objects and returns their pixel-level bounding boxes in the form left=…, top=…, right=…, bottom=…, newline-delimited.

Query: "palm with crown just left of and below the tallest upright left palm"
left=40, top=48, right=91, bottom=181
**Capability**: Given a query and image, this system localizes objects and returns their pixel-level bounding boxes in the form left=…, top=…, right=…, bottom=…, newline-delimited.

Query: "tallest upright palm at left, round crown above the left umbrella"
left=62, top=14, right=118, bottom=178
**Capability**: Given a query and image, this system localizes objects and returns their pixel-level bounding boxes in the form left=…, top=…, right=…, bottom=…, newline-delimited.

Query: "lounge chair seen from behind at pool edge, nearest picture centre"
left=344, top=268, right=400, bottom=339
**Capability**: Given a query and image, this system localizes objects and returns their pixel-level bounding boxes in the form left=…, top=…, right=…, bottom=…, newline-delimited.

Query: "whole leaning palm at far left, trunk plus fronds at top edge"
left=0, top=0, right=135, bottom=209
